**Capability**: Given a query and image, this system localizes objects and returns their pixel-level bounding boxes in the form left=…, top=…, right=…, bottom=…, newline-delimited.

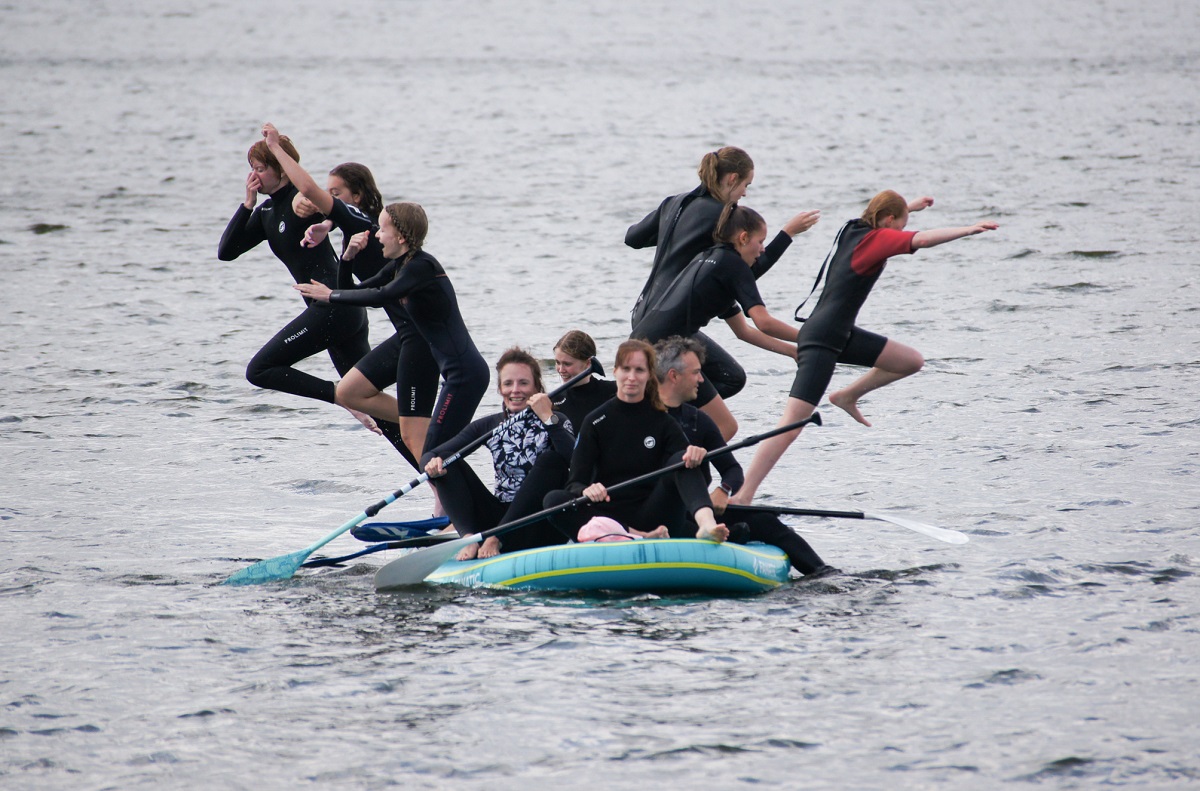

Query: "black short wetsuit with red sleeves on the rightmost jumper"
left=790, top=220, right=917, bottom=406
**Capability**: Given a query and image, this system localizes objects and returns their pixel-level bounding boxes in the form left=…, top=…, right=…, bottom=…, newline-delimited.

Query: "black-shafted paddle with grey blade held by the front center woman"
left=376, top=412, right=821, bottom=591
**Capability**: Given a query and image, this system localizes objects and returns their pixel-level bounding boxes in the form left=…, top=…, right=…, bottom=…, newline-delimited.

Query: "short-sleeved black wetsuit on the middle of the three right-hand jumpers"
left=631, top=242, right=772, bottom=407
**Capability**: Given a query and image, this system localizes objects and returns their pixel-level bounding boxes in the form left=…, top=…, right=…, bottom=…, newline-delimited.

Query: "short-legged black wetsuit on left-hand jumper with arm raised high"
left=329, top=198, right=440, bottom=418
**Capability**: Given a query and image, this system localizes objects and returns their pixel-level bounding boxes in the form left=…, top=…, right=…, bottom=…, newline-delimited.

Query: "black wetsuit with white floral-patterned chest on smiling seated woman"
left=421, top=409, right=575, bottom=552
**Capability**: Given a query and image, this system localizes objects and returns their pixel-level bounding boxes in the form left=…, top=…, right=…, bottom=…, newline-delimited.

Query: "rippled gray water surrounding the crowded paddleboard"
left=0, top=0, right=1200, bottom=791
